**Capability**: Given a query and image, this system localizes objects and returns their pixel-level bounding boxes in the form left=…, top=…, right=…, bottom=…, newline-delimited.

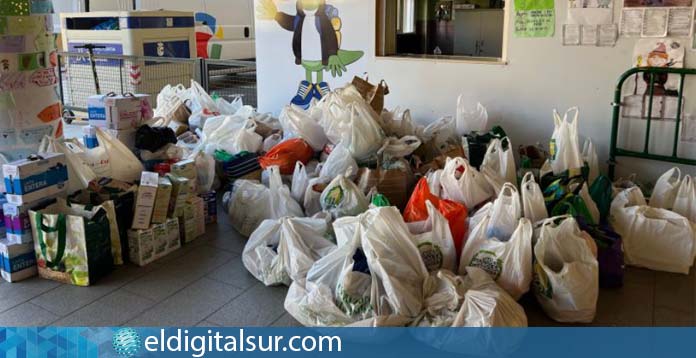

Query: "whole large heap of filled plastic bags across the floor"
left=118, top=79, right=696, bottom=327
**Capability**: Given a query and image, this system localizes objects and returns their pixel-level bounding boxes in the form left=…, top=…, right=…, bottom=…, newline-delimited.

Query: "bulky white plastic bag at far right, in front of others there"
left=610, top=187, right=696, bottom=274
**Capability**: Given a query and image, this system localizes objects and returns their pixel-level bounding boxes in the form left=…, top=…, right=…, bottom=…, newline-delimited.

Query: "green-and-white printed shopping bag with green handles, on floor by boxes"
left=30, top=200, right=113, bottom=286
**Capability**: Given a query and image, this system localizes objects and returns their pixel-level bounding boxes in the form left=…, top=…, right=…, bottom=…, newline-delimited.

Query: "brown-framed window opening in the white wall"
left=376, top=0, right=506, bottom=61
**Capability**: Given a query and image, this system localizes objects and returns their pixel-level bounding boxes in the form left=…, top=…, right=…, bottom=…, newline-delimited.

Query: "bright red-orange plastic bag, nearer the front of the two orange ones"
left=404, top=178, right=469, bottom=253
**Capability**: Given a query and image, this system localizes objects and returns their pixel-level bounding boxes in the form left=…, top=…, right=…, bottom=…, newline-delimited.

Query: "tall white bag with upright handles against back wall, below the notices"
left=549, top=107, right=584, bottom=175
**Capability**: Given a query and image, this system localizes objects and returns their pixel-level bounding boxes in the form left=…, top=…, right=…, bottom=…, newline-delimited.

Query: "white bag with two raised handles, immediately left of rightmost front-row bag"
left=459, top=216, right=534, bottom=300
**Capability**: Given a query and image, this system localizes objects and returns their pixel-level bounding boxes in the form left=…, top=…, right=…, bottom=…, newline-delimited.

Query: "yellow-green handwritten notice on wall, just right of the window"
left=514, top=0, right=556, bottom=37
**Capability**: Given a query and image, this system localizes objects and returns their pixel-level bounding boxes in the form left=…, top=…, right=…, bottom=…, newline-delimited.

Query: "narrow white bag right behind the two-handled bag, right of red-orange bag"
left=486, top=183, right=522, bottom=241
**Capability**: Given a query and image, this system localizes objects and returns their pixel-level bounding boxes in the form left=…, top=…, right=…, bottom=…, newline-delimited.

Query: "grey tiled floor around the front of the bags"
left=0, top=210, right=696, bottom=327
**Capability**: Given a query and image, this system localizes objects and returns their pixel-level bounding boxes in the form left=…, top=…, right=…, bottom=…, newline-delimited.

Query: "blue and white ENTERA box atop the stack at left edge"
left=2, top=153, right=68, bottom=205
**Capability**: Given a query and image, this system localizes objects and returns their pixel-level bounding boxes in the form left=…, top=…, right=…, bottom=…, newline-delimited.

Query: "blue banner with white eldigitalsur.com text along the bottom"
left=0, top=327, right=696, bottom=358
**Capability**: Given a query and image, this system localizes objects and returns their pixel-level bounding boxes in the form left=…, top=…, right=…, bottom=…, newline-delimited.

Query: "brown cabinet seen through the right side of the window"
left=453, top=9, right=505, bottom=57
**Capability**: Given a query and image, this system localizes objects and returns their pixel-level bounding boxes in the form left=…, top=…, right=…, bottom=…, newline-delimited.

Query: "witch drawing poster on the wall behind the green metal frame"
left=624, top=38, right=685, bottom=119
